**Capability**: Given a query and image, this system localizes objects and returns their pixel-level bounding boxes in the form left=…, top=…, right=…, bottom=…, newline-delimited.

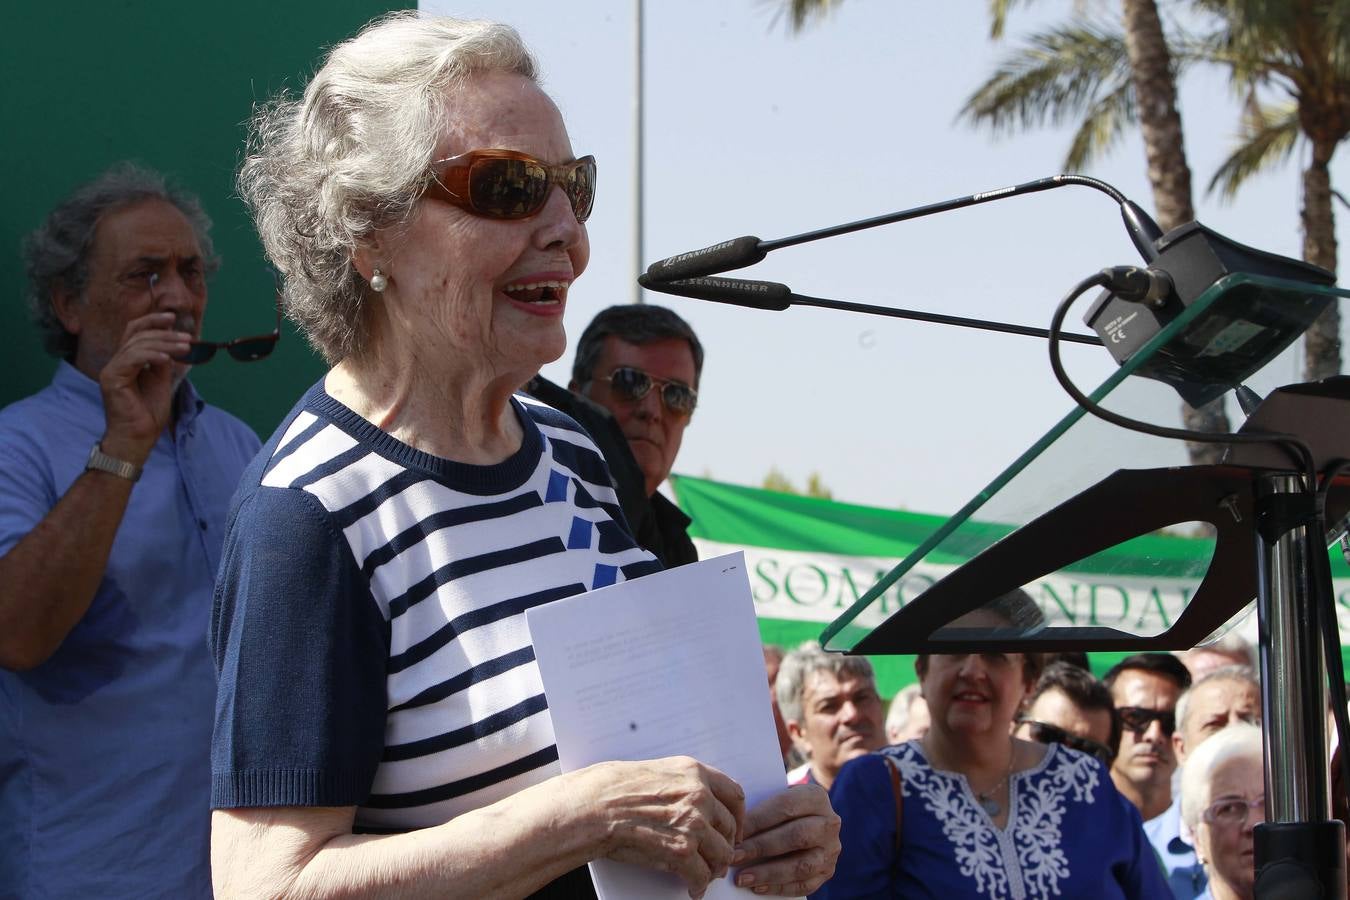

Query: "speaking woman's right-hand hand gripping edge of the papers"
left=733, top=784, right=840, bottom=897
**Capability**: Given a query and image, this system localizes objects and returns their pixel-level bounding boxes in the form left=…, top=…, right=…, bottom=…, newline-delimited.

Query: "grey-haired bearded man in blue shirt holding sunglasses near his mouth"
left=0, top=165, right=259, bottom=897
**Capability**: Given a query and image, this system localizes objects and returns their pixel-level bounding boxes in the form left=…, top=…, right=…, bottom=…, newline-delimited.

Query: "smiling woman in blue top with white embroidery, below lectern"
left=813, top=591, right=1170, bottom=900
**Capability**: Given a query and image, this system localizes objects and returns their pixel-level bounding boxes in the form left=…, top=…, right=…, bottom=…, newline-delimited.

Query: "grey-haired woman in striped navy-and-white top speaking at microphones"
left=211, top=13, right=838, bottom=897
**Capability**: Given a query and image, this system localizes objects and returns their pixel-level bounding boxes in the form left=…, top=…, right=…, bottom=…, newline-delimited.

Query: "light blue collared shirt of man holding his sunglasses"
left=0, top=363, right=259, bottom=900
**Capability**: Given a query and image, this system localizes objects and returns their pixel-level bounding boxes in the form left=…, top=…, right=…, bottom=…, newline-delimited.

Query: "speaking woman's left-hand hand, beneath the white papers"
left=576, top=757, right=750, bottom=897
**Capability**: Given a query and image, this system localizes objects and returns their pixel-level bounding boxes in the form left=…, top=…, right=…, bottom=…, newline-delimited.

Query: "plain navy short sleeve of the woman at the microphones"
left=209, top=487, right=389, bottom=808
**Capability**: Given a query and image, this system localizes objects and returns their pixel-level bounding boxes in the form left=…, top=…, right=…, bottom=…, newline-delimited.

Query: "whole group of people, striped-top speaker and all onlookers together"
left=0, top=7, right=1333, bottom=900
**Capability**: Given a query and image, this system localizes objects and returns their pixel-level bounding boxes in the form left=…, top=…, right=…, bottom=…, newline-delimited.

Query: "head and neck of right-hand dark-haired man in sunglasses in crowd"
left=1102, top=653, right=1191, bottom=823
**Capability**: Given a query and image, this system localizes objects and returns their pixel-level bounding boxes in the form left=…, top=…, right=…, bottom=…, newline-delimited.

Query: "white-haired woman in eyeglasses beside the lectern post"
left=1181, top=723, right=1265, bottom=900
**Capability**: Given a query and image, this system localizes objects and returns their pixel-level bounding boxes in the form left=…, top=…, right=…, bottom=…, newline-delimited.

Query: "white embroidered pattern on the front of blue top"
left=886, top=743, right=1099, bottom=900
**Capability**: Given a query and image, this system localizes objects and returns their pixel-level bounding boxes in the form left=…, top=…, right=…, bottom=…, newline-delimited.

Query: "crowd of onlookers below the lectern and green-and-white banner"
left=775, top=634, right=1285, bottom=900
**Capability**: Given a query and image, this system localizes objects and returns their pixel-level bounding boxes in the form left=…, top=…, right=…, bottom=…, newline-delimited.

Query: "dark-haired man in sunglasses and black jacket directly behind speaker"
left=561, top=304, right=703, bottom=568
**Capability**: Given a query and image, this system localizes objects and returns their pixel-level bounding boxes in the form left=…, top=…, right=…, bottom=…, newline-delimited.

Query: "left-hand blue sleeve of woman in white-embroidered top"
left=811, top=753, right=895, bottom=900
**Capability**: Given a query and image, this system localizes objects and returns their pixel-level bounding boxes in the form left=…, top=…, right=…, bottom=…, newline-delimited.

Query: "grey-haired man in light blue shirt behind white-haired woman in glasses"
left=1143, top=665, right=1261, bottom=900
